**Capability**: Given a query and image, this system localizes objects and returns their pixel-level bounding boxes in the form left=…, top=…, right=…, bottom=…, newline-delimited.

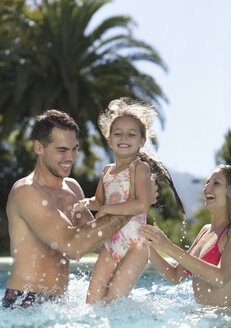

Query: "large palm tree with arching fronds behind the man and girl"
left=0, top=0, right=167, bottom=156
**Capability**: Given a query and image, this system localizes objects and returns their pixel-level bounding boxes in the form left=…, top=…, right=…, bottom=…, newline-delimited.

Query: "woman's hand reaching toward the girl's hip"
left=141, top=222, right=171, bottom=251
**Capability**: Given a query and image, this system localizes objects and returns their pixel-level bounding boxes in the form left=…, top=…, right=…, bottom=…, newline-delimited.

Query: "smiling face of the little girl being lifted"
left=108, top=116, right=146, bottom=158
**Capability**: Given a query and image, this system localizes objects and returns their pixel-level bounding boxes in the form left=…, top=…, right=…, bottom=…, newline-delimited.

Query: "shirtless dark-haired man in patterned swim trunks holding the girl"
left=2, top=110, right=157, bottom=307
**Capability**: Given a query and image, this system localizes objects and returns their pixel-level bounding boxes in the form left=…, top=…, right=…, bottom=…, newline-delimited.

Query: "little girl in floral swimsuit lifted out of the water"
left=75, top=98, right=183, bottom=304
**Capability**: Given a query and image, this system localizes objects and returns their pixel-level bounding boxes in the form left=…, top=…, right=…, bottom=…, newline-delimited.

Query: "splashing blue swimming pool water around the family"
left=0, top=258, right=231, bottom=328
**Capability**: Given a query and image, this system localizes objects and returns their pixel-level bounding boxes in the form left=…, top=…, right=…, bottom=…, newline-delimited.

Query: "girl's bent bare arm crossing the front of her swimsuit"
left=96, top=161, right=152, bottom=218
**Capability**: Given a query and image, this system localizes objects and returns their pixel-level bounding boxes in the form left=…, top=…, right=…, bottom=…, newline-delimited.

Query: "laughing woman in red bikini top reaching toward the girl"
left=142, top=164, right=231, bottom=306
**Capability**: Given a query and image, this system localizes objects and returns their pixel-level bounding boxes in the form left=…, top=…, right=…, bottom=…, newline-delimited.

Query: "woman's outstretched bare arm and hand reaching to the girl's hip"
left=142, top=225, right=231, bottom=288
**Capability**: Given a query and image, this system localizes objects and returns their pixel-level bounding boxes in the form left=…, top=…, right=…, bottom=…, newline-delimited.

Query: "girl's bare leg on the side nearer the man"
left=87, top=246, right=118, bottom=304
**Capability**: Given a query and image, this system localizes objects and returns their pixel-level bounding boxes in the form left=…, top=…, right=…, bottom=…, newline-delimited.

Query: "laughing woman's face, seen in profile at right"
left=204, top=169, right=227, bottom=212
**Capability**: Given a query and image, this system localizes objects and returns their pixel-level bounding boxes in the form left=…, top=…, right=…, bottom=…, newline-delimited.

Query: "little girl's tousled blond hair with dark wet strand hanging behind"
left=98, top=97, right=185, bottom=215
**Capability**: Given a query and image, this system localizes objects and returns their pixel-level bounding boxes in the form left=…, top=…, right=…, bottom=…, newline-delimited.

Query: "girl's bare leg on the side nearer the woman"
left=106, top=244, right=148, bottom=303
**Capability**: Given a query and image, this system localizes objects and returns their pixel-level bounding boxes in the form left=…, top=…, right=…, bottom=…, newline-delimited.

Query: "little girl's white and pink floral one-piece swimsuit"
left=103, top=165, right=146, bottom=262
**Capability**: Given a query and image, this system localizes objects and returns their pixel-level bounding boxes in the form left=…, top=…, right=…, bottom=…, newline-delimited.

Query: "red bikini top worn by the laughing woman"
left=186, top=223, right=231, bottom=276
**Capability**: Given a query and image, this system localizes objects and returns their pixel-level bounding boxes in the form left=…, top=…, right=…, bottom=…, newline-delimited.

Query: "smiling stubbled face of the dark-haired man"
left=41, top=128, right=78, bottom=178
